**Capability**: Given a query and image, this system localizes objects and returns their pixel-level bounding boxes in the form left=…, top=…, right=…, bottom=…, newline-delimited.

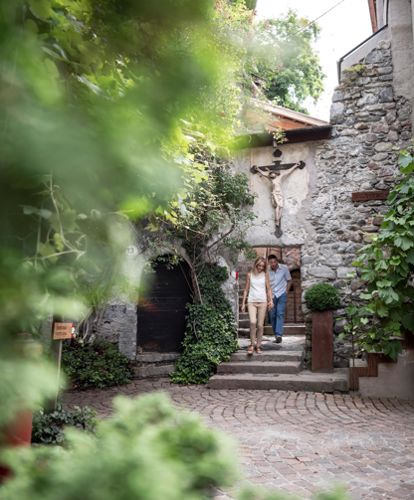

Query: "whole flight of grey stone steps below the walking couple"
left=208, top=334, right=348, bottom=392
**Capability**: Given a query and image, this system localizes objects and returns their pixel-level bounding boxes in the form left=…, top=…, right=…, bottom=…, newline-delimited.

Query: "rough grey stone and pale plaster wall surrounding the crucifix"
left=94, top=41, right=412, bottom=366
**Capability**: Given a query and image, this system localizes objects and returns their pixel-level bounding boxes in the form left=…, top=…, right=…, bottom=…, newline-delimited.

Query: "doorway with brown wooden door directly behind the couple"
left=240, top=246, right=303, bottom=324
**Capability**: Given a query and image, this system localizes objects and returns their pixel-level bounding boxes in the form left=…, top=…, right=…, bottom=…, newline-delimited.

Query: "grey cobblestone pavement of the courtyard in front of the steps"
left=65, top=379, right=414, bottom=500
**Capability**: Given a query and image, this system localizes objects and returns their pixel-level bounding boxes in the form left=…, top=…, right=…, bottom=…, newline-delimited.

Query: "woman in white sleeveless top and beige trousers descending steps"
left=241, top=257, right=273, bottom=354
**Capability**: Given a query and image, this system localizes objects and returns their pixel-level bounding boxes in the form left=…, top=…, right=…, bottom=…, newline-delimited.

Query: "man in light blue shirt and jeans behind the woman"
left=268, top=255, right=292, bottom=344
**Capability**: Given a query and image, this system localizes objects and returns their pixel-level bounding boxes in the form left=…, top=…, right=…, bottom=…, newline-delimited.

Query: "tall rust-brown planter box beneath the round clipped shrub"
left=312, top=311, right=333, bottom=373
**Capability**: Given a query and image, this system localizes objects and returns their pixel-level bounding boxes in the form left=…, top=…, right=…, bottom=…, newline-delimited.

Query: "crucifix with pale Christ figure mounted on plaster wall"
left=250, top=149, right=305, bottom=238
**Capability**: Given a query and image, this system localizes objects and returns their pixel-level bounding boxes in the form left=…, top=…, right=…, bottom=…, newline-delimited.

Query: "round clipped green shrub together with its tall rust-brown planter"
left=305, top=283, right=340, bottom=372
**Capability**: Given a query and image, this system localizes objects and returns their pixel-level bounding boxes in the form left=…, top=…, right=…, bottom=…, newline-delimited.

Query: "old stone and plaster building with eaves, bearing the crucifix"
left=98, top=0, right=414, bottom=390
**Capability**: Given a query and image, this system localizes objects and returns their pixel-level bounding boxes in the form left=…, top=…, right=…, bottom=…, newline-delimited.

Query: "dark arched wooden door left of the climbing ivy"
left=137, top=262, right=191, bottom=352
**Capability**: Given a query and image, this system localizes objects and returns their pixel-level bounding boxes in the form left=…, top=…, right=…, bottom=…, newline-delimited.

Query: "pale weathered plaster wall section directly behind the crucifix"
left=235, top=142, right=316, bottom=246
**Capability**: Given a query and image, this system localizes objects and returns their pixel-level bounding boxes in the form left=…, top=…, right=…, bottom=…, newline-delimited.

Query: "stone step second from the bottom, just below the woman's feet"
left=217, top=360, right=301, bottom=374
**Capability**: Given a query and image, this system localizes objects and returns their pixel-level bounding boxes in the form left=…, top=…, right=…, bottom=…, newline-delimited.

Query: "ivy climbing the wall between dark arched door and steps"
left=143, top=143, right=254, bottom=383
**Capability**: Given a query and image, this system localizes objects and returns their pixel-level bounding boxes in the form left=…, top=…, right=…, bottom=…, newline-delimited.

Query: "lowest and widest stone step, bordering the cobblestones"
left=208, top=368, right=348, bottom=392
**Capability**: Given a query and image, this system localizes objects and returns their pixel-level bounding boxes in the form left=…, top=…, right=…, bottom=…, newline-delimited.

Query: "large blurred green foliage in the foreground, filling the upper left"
left=0, top=0, right=241, bottom=422
